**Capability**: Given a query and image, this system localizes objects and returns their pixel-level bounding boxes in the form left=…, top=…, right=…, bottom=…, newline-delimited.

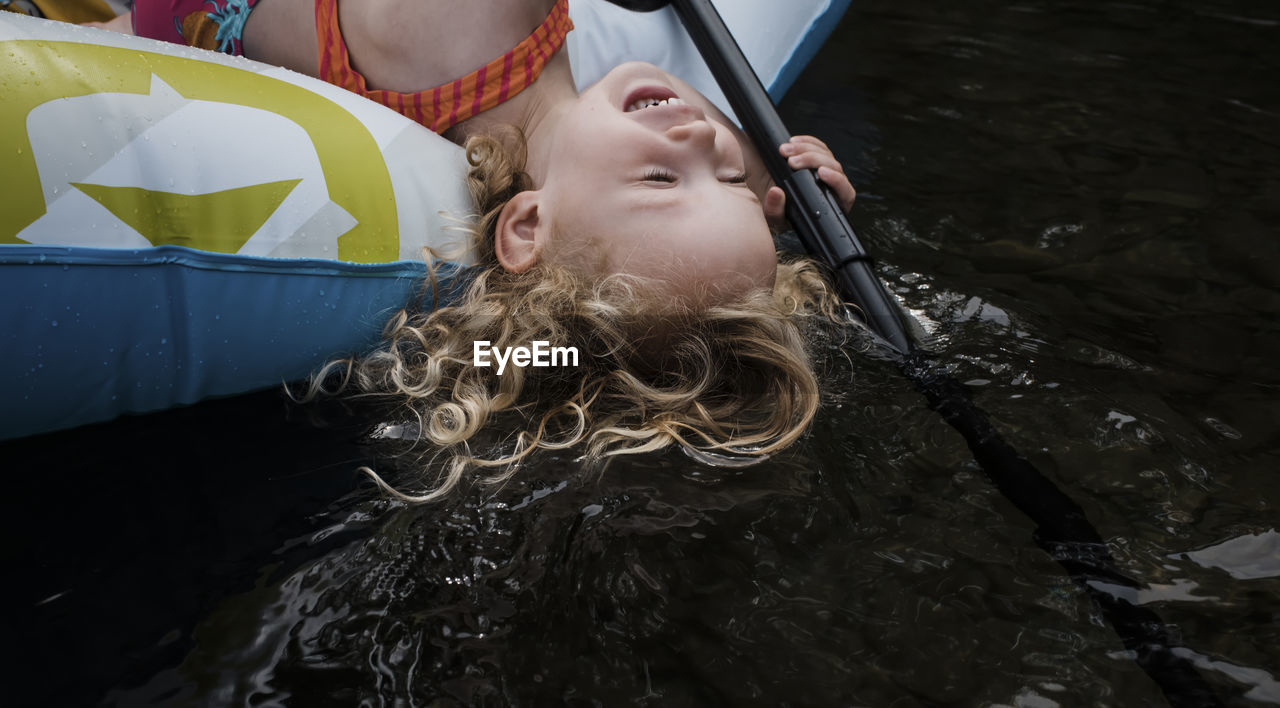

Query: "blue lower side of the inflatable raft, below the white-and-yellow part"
left=0, top=246, right=452, bottom=437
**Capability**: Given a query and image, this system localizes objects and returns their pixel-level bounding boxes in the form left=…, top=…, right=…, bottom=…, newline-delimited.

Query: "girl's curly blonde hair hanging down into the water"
left=306, top=129, right=845, bottom=502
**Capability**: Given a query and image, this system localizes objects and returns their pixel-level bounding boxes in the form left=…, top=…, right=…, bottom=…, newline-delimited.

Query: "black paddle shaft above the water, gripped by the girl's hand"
left=672, top=0, right=913, bottom=355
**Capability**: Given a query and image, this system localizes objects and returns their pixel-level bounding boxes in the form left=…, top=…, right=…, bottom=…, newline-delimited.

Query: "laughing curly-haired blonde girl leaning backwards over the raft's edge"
left=92, top=0, right=854, bottom=501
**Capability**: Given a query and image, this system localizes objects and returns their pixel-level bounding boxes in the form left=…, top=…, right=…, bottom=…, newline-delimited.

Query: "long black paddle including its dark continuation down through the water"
left=670, top=0, right=1220, bottom=708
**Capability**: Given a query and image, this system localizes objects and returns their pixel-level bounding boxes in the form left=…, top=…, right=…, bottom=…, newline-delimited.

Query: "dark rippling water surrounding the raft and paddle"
left=0, top=0, right=1280, bottom=708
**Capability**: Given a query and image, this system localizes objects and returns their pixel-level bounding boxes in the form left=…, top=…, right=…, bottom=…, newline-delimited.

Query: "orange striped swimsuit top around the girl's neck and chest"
left=316, top=0, right=573, bottom=133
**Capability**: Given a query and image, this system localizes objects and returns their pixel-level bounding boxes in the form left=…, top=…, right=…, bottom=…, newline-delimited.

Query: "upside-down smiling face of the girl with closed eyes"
left=524, top=63, right=777, bottom=300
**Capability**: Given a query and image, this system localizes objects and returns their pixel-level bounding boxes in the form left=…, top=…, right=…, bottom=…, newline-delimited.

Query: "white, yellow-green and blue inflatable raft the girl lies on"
left=0, top=0, right=847, bottom=438
